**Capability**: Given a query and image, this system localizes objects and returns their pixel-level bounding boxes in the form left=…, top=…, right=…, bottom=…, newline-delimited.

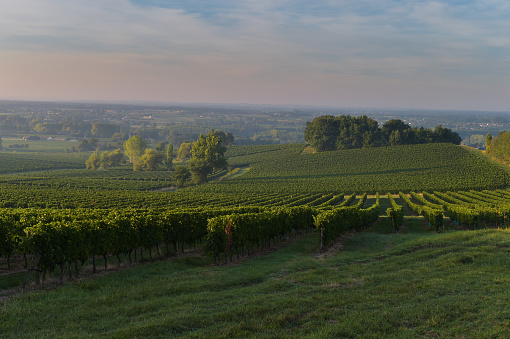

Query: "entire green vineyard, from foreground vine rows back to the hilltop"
left=0, top=144, right=510, bottom=338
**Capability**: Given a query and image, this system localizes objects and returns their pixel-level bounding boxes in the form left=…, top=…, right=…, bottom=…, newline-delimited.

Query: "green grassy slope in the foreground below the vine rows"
left=0, top=222, right=510, bottom=338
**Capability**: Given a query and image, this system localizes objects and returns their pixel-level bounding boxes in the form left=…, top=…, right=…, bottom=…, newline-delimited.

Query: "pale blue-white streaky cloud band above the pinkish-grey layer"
left=0, top=0, right=510, bottom=60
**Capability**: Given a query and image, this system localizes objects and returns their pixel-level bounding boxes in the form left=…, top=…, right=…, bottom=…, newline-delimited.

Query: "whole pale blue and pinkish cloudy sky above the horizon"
left=0, top=0, right=510, bottom=111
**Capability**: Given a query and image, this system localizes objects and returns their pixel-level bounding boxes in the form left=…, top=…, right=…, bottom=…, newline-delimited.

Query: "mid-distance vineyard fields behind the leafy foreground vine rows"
left=0, top=144, right=510, bottom=208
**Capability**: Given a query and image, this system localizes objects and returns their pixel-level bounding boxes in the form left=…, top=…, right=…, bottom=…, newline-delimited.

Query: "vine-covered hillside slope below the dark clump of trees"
left=200, top=144, right=510, bottom=193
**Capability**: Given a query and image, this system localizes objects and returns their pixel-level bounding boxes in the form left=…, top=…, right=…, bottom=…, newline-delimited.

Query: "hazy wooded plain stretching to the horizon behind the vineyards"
left=0, top=101, right=510, bottom=150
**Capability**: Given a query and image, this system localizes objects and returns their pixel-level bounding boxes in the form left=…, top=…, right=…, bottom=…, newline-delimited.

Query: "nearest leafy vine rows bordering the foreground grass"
left=0, top=190, right=510, bottom=282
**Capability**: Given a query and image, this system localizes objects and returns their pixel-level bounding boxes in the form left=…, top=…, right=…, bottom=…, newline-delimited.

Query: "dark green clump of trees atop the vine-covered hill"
left=304, top=115, right=462, bottom=152
